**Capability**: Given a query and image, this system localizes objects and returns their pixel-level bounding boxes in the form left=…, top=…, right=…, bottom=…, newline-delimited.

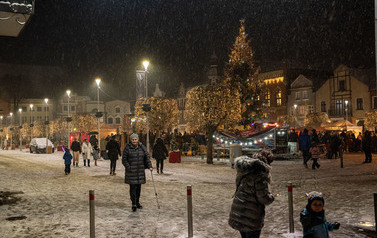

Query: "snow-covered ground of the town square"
left=0, top=150, right=377, bottom=238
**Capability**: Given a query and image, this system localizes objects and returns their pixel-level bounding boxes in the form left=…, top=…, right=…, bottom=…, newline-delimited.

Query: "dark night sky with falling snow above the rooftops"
left=0, top=0, right=374, bottom=100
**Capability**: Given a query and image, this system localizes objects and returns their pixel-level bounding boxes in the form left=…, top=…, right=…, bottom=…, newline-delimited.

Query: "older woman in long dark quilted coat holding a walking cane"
left=122, top=134, right=153, bottom=212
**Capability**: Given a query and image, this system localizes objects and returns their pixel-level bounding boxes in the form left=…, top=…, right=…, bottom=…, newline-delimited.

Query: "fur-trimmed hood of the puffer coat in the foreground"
left=234, top=155, right=271, bottom=174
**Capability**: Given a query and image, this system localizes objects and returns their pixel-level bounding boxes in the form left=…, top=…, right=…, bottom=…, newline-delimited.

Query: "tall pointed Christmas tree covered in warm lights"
left=225, top=20, right=263, bottom=123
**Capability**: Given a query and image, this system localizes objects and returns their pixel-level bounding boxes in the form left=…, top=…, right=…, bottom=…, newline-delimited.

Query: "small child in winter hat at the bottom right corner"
left=300, top=191, right=340, bottom=238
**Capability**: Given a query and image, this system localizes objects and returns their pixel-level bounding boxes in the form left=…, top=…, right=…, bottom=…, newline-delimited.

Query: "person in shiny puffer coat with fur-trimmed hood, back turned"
left=228, top=151, right=274, bottom=238
